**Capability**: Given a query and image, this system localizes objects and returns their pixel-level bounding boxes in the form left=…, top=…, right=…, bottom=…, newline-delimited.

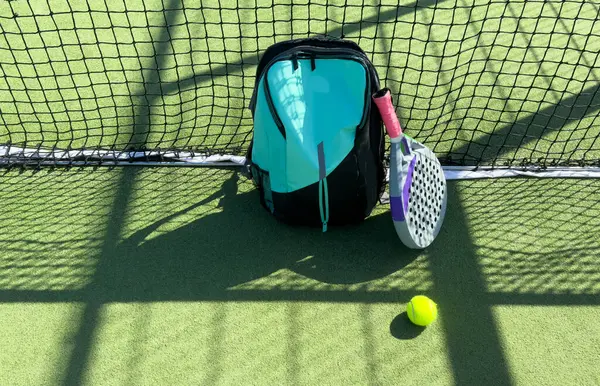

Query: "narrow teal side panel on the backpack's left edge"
left=252, top=74, right=288, bottom=193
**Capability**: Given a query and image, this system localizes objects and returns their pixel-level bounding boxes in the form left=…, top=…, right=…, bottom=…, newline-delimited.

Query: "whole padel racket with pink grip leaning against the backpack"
left=373, top=88, right=447, bottom=249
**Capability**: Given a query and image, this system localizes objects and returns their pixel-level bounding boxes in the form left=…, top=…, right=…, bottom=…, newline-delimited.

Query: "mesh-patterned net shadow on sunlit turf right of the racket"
left=460, top=179, right=600, bottom=298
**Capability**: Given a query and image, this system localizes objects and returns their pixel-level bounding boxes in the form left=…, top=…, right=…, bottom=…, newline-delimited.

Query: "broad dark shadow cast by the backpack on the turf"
left=96, top=173, right=418, bottom=301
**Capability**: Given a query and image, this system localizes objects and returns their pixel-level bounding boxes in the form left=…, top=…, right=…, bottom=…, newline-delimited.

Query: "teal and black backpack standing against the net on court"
left=246, top=38, right=385, bottom=231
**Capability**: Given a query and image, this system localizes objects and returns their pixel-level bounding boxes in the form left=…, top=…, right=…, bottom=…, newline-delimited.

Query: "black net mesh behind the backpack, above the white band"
left=0, top=0, right=600, bottom=166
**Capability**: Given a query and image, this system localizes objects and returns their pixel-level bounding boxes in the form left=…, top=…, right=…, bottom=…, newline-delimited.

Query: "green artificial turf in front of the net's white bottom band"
left=0, top=167, right=600, bottom=385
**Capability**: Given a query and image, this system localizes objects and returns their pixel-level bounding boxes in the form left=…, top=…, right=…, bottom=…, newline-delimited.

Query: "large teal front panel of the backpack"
left=267, top=59, right=367, bottom=191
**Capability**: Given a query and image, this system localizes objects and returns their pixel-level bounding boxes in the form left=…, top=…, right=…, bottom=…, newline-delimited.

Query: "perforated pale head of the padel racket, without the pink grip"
left=394, top=140, right=447, bottom=249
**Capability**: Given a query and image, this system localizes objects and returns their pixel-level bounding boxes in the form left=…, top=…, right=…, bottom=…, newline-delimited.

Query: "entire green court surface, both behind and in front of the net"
left=0, top=0, right=600, bottom=386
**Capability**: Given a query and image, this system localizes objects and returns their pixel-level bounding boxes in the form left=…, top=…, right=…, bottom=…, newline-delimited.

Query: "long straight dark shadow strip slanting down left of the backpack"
left=56, top=0, right=192, bottom=384
